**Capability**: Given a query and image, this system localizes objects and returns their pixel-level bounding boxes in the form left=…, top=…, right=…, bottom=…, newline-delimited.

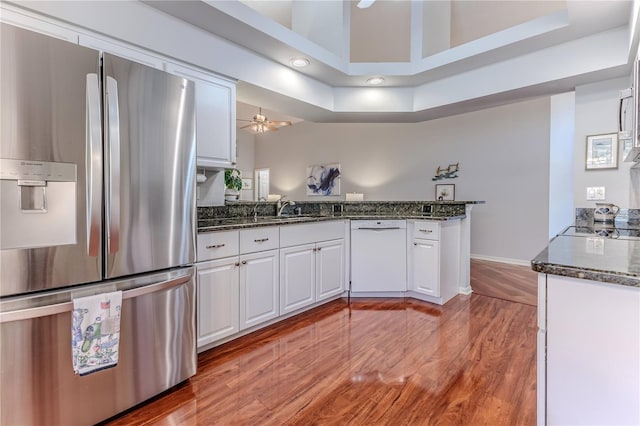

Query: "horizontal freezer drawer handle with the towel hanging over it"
left=0, top=273, right=192, bottom=324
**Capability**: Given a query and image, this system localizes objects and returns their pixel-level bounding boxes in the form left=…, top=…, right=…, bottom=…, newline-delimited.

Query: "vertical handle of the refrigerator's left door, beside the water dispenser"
left=86, top=74, right=102, bottom=257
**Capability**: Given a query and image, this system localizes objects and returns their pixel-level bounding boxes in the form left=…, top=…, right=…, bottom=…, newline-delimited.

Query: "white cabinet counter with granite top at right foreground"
left=531, top=218, right=640, bottom=425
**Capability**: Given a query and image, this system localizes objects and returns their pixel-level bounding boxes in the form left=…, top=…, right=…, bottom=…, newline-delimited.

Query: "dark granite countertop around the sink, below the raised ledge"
left=198, top=214, right=466, bottom=233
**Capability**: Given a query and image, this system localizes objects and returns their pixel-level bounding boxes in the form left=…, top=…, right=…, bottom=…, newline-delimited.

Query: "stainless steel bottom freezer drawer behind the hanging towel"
left=0, top=268, right=196, bottom=425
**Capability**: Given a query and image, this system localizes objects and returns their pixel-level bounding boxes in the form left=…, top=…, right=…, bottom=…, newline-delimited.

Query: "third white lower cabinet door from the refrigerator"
left=280, top=244, right=316, bottom=315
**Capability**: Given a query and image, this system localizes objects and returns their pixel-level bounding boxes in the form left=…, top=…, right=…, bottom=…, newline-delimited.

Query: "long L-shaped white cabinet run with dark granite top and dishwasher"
left=197, top=201, right=482, bottom=352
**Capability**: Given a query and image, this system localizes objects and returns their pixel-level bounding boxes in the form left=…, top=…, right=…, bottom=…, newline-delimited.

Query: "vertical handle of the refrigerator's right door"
left=106, top=76, right=120, bottom=254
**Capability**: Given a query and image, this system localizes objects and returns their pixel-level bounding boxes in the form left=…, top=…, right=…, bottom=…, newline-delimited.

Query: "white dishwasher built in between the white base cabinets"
left=351, top=220, right=407, bottom=293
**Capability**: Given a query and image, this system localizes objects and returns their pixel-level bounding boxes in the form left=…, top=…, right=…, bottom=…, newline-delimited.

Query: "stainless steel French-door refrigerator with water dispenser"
left=0, top=24, right=196, bottom=425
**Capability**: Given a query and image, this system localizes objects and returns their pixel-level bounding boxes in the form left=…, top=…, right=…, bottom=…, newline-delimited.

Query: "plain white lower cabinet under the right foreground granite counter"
left=538, top=275, right=640, bottom=425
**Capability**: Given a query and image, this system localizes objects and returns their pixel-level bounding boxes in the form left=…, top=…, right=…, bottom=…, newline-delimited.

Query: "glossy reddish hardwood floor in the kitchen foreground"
left=109, top=294, right=536, bottom=426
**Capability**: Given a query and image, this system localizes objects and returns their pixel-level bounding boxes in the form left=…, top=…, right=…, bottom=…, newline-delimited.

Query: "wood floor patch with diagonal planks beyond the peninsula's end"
left=471, top=259, right=538, bottom=306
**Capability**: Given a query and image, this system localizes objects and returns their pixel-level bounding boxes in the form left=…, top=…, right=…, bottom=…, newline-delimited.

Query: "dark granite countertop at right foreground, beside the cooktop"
left=531, top=222, right=640, bottom=287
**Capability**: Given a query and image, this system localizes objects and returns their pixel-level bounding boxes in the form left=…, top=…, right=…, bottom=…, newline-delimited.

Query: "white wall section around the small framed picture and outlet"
left=573, top=78, right=633, bottom=208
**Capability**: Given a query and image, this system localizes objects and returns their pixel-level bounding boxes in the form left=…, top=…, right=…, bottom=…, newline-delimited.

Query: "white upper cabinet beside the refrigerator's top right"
left=167, top=64, right=236, bottom=169
